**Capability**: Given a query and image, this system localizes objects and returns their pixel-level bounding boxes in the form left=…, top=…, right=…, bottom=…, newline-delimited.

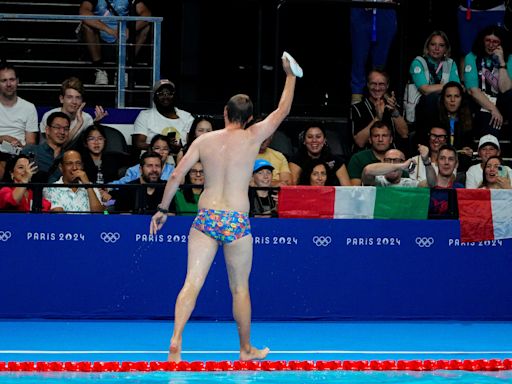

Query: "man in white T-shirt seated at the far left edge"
left=0, top=62, right=39, bottom=179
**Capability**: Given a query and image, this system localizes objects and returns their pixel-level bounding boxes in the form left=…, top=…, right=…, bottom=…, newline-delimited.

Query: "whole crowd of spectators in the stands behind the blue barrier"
left=0, top=0, right=512, bottom=217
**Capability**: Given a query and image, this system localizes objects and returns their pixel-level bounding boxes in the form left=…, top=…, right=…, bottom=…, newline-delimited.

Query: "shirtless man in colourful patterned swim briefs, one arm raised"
left=150, top=54, right=296, bottom=361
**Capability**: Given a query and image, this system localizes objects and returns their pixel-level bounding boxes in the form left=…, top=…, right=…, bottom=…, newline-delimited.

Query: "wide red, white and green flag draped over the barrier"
left=278, top=186, right=430, bottom=220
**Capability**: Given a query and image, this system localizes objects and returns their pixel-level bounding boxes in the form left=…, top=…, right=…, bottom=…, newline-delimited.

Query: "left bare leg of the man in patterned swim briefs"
left=168, top=228, right=218, bottom=361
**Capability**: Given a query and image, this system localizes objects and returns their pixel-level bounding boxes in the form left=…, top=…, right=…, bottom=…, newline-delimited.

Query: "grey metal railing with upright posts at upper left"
left=0, top=13, right=163, bottom=108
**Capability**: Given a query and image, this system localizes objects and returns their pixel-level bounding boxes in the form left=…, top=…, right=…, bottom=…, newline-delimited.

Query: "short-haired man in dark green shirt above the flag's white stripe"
left=348, top=120, right=393, bottom=186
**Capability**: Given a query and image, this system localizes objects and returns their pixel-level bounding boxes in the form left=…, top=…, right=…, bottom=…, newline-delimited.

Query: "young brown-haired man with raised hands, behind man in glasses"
left=39, top=77, right=108, bottom=148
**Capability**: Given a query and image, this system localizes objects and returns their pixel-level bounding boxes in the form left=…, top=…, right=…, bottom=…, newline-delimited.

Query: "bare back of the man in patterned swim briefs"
left=196, top=127, right=261, bottom=212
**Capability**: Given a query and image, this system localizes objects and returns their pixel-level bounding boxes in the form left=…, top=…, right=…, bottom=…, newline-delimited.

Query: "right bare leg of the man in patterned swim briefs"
left=224, top=235, right=269, bottom=360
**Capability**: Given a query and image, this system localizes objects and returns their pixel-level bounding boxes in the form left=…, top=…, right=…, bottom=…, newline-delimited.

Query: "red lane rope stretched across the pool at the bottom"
left=0, top=359, right=512, bottom=372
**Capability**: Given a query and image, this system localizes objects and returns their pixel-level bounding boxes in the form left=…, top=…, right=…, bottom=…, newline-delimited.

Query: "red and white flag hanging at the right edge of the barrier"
left=457, top=189, right=512, bottom=242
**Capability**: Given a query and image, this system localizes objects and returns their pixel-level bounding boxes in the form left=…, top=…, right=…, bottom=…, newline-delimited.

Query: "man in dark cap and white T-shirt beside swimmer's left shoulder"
left=133, top=79, right=194, bottom=160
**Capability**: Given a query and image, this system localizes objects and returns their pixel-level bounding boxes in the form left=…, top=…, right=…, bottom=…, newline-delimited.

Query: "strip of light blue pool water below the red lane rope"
left=4, top=371, right=512, bottom=384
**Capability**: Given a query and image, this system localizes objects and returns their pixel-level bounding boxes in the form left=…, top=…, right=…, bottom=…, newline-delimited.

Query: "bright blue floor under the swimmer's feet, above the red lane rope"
left=0, top=320, right=512, bottom=362
